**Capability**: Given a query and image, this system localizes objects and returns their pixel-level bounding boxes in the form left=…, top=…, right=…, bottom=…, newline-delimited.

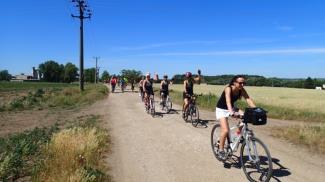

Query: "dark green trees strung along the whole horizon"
left=0, top=63, right=325, bottom=89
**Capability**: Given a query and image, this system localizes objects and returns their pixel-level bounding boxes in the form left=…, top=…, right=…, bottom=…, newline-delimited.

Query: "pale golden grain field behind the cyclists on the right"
left=162, top=84, right=325, bottom=114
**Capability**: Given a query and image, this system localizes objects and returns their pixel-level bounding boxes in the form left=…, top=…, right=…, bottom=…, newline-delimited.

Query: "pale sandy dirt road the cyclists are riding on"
left=100, top=87, right=325, bottom=182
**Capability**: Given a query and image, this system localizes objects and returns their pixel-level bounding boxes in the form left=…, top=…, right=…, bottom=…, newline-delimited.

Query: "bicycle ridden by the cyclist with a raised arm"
left=183, top=94, right=202, bottom=127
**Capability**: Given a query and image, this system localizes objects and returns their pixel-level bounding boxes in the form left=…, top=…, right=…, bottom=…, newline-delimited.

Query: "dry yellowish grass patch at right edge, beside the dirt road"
left=272, top=124, right=325, bottom=154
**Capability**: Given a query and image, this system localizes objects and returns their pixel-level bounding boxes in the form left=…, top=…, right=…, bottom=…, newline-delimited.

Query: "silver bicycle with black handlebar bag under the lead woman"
left=211, top=108, right=273, bottom=181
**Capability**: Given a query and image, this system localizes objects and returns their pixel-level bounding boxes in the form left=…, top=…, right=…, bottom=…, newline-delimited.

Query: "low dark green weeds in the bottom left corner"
left=0, top=125, right=58, bottom=181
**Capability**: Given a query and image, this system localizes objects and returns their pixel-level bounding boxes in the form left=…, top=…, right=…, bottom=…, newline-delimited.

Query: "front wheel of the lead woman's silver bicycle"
left=240, top=137, right=273, bottom=182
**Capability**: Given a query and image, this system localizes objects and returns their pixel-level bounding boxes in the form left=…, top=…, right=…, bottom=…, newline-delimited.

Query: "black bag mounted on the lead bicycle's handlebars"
left=244, top=107, right=267, bottom=125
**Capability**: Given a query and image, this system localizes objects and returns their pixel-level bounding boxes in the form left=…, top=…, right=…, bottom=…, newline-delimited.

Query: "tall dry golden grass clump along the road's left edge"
left=35, top=127, right=108, bottom=182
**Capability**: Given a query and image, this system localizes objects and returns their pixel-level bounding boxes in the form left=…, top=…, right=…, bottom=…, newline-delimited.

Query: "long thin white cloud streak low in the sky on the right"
left=130, top=48, right=325, bottom=56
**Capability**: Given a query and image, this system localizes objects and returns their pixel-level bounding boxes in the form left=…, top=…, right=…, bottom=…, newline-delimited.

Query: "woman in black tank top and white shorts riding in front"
left=216, top=75, right=256, bottom=159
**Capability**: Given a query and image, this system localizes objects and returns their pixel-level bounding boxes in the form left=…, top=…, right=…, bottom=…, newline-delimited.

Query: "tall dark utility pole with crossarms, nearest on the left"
left=71, top=0, right=91, bottom=91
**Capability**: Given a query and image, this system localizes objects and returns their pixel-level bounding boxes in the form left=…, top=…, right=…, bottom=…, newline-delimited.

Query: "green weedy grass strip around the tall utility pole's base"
left=0, top=83, right=108, bottom=112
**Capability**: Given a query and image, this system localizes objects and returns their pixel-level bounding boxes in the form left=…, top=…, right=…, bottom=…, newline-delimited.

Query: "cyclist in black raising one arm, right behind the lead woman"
left=183, top=72, right=201, bottom=118
